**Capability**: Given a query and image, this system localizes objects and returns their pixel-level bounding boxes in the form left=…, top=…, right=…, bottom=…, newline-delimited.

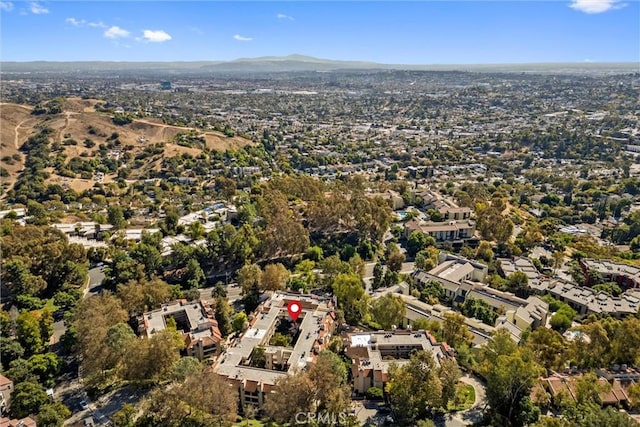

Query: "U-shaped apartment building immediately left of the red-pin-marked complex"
left=138, top=300, right=222, bottom=360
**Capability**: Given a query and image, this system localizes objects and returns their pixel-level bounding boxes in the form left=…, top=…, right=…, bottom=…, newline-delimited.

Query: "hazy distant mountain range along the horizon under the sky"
left=0, top=55, right=640, bottom=74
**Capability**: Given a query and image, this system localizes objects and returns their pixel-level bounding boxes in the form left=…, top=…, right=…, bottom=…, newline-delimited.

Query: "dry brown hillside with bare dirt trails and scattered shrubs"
left=0, top=98, right=252, bottom=195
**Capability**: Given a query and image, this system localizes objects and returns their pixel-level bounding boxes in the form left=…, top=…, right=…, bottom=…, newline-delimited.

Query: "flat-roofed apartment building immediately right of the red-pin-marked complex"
left=346, top=330, right=453, bottom=394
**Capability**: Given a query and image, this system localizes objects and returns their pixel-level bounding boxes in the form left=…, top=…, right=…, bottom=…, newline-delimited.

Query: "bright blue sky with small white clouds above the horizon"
left=0, top=0, right=640, bottom=64
